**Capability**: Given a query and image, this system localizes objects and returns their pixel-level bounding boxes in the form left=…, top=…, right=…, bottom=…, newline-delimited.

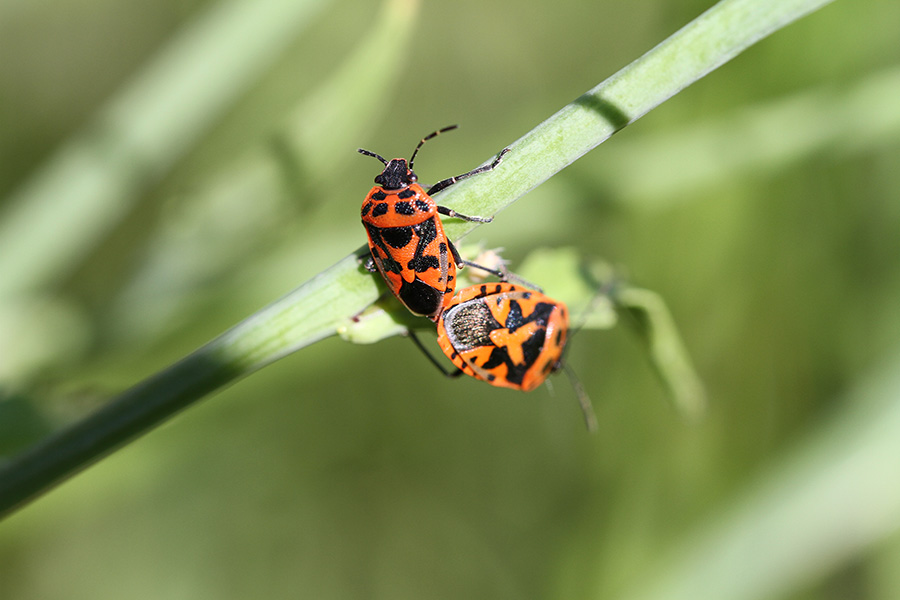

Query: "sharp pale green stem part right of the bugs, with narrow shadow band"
left=441, top=0, right=832, bottom=239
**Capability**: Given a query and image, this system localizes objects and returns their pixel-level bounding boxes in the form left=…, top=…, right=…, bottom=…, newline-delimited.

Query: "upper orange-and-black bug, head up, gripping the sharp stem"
left=359, top=125, right=509, bottom=321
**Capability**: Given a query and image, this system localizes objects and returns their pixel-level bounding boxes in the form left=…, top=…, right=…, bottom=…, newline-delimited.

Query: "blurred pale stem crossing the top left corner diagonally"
left=0, top=0, right=323, bottom=300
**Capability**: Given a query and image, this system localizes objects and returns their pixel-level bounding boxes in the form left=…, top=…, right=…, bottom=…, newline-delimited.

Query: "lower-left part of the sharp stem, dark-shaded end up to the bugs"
left=0, top=255, right=381, bottom=518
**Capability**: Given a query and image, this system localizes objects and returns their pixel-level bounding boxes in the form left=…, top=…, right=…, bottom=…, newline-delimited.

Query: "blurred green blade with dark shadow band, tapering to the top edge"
left=110, top=0, right=418, bottom=346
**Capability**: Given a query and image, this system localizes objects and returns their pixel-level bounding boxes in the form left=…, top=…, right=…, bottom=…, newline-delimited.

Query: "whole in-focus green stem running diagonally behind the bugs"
left=0, top=0, right=830, bottom=516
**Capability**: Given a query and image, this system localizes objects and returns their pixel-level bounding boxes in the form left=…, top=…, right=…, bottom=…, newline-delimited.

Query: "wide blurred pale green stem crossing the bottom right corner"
left=608, top=354, right=900, bottom=600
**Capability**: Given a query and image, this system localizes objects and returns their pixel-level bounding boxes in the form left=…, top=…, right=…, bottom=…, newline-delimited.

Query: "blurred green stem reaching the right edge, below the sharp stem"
left=579, top=65, right=900, bottom=210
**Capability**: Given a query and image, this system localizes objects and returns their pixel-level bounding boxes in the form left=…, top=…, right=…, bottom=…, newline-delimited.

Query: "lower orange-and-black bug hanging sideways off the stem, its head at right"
left=438, top=282, right=569, bottom=392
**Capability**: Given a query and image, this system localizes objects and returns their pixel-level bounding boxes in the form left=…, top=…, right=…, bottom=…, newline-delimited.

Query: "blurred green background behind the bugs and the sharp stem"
left=0, top=0, right=900, bottom=600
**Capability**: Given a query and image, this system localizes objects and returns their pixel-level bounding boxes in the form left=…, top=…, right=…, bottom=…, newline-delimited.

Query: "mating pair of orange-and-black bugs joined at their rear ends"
left=359, top=125, right=593, bottom=427
